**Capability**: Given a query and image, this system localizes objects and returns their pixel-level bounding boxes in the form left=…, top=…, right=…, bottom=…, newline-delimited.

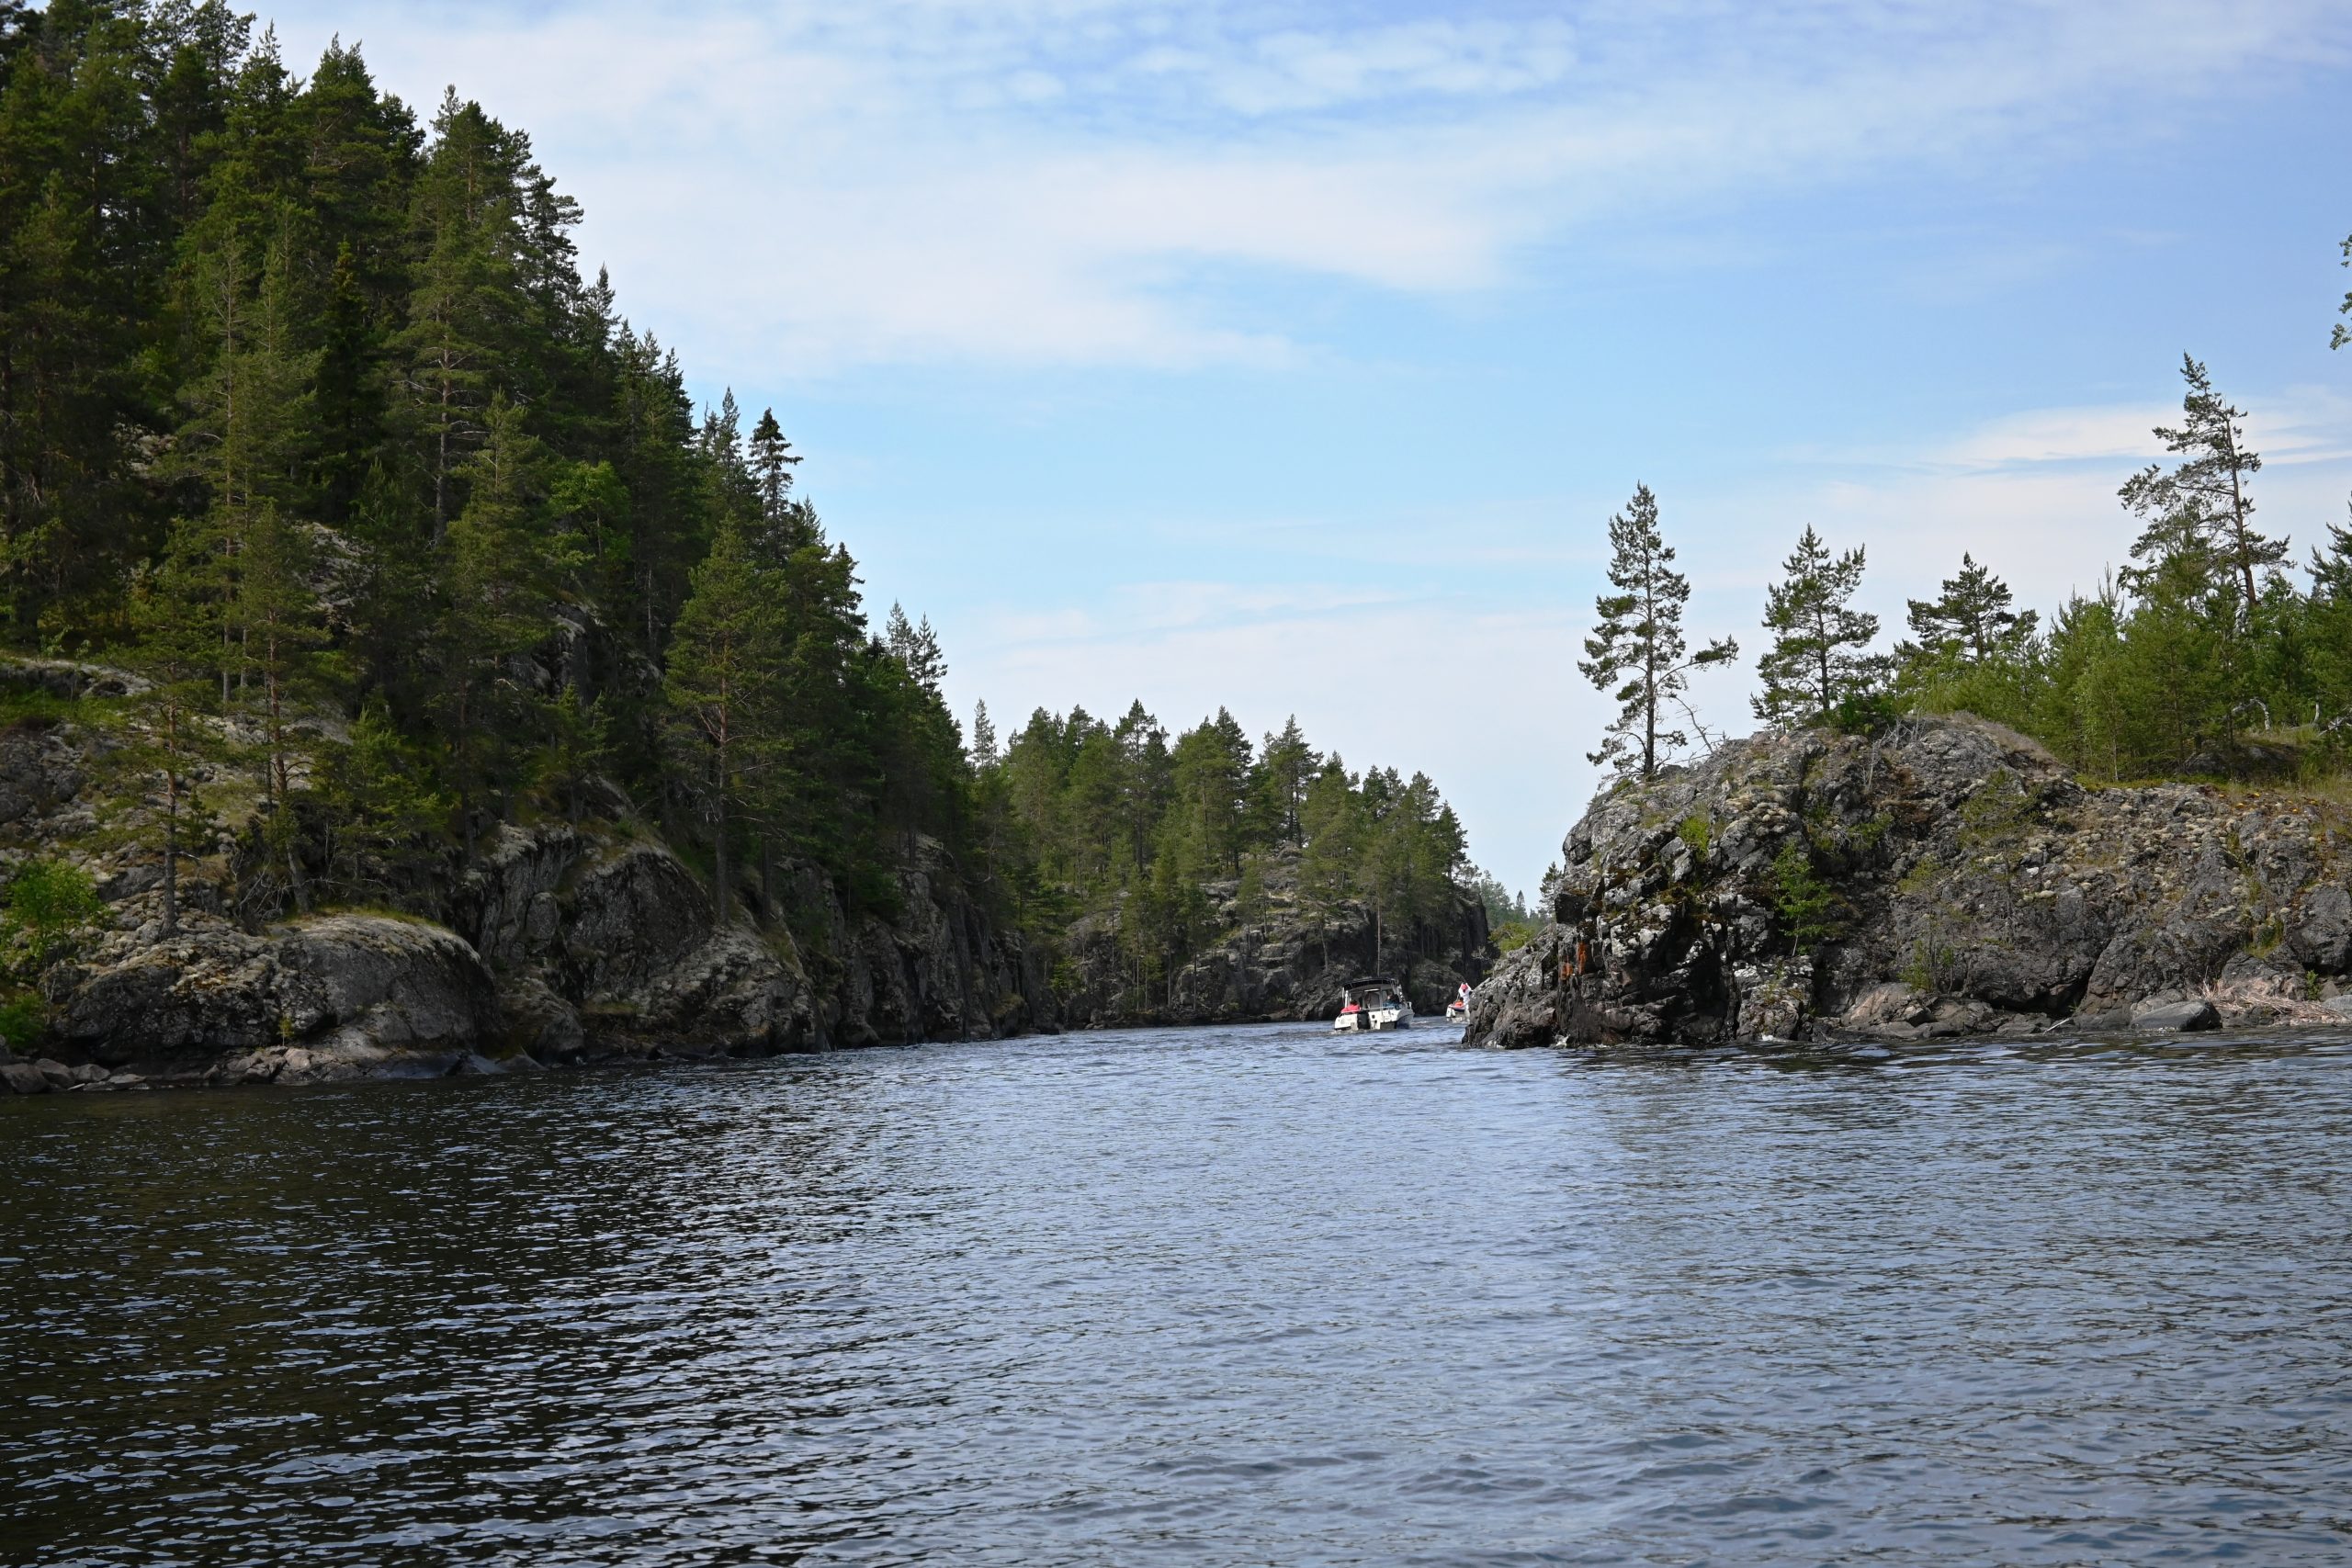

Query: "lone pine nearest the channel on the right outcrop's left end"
left=1576, top=484, right=1740, bottom=778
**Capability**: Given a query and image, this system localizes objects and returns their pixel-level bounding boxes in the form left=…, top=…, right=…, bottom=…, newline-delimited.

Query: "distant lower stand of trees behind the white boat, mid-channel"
left=974, top=703, right=1467, bottom=995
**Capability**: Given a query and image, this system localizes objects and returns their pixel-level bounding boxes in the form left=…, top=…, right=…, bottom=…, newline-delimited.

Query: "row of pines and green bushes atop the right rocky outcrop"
left=1583, top=350, right=2352, bottom=778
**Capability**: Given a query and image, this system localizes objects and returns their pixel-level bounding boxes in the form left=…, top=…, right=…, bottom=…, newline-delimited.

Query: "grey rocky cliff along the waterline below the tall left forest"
left=0, top=700, right=1058, bottom=1090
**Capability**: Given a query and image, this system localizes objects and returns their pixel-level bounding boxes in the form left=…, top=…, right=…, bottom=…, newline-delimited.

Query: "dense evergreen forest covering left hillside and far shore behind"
left=0, top=0, right=1465, bottom=991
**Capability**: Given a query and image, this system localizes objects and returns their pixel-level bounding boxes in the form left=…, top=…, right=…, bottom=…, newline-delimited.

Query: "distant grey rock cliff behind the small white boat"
left=1054, top=846, right=1494, bottom=1027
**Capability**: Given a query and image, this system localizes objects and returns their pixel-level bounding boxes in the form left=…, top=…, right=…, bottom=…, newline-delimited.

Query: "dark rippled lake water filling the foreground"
left=0, top=1027, right=2352, bottom=1568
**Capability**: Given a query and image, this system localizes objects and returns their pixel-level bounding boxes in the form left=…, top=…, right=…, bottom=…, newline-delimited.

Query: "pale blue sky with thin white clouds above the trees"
left=264, top=0, right=2352, bottom=888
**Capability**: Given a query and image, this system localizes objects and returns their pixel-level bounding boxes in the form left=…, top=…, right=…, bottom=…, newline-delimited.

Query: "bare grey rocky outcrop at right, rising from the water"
left=1467, top=715, right=2352, bottom=1046
